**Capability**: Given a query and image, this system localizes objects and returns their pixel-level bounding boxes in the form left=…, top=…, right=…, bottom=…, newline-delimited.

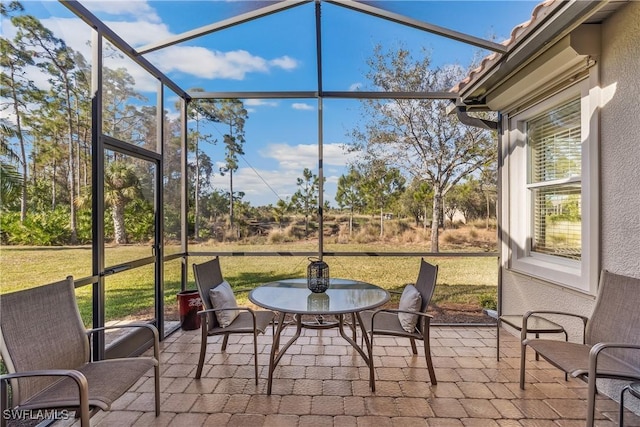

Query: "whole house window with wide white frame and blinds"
left=502, top=76, right=599, bottom=292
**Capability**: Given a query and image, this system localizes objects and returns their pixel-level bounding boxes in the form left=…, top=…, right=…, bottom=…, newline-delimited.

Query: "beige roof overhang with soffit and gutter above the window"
left=452, top=0, right=628, bottom=111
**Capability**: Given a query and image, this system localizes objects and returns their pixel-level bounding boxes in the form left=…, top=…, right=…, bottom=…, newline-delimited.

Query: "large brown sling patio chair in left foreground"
left=0, top=276, right=160, bottom=427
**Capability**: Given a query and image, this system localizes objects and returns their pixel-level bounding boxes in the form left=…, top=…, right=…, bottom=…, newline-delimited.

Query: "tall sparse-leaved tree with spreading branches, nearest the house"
left=353, top=46, right=496, bottom=252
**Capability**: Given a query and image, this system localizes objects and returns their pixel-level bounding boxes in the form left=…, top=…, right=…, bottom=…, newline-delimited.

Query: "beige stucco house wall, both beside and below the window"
left=501, top=2, right=640, bottom=337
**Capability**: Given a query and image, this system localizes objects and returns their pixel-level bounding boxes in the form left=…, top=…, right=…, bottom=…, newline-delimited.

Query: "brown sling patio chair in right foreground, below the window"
left=520, top=270, right=640, bottom=427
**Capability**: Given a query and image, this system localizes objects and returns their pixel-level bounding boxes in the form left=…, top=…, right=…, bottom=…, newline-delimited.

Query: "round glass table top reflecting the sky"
left=249, top=278, right=390, bottom=315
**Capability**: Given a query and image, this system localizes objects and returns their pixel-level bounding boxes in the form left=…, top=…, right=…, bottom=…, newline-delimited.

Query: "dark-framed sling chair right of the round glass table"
left=360, top=259, right=438, bottom=385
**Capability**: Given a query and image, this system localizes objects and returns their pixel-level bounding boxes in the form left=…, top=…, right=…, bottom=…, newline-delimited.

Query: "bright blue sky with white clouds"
left=10, top=0, right=537, bottom=206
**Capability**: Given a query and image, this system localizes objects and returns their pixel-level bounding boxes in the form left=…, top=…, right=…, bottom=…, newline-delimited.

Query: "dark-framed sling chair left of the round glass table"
left=193, top=257, right=275, bottom=384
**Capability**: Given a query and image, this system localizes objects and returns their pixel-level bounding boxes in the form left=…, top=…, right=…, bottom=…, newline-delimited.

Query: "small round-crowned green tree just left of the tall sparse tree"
left=360, top=159, right=406, bottom=237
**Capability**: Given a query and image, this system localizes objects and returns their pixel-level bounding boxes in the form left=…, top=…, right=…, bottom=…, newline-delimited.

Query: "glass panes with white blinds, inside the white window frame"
left=526, top=98, right=582, bottom=260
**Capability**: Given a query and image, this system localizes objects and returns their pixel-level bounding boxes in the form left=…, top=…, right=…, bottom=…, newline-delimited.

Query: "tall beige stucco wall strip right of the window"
left=600, top=1, right=640, bottom=276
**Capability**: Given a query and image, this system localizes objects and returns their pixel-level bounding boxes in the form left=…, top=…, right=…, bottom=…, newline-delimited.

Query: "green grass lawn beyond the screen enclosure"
left=0, top=242, right=498, bottom=325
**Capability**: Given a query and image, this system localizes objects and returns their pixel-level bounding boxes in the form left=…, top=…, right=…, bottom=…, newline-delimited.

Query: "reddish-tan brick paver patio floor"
left=58, top=326, right=640, bottom=427
